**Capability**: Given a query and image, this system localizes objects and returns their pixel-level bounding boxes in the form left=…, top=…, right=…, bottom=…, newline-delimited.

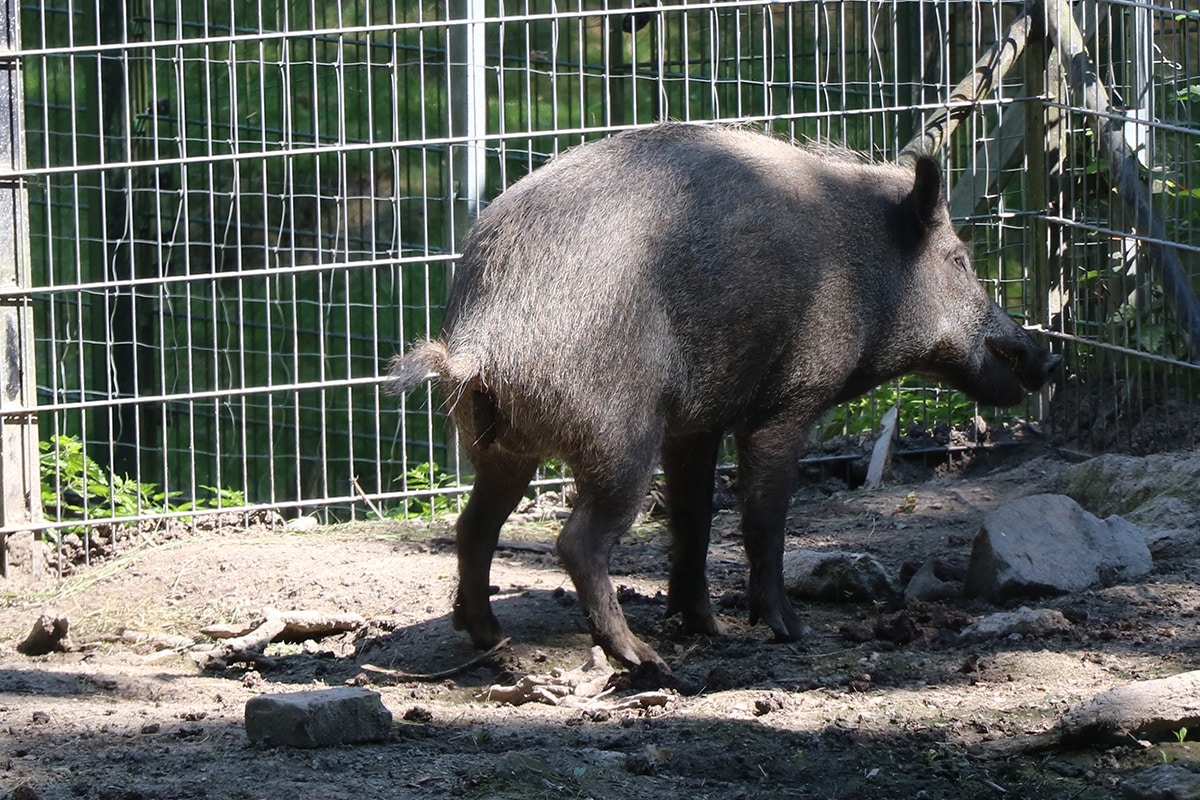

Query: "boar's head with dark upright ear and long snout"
left=895, top=156, right=1061, bottom=405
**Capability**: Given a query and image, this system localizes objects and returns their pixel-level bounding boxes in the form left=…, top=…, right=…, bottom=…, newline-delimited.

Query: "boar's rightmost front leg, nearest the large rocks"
left=737, top=426, right=808, bottom=642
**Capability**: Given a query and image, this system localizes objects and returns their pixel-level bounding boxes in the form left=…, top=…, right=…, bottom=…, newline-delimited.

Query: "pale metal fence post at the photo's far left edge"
left=0, top=0, right=42, bottom=577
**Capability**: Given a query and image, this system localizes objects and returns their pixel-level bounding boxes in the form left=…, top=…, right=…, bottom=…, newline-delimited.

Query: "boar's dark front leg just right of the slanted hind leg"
left=662, top=433, right=725, bottom=636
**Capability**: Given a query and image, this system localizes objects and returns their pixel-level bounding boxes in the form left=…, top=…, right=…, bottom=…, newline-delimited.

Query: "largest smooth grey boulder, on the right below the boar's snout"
left=962, top=494, right=1153, bottom=601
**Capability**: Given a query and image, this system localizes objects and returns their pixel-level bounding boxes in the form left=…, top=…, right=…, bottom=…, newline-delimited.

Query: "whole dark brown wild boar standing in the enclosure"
left=391, top=124, right=1058, bottom=669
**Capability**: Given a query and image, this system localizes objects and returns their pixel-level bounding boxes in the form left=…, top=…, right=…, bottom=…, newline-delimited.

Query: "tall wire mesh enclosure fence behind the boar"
left=0, top=0, right=1200, bottom=575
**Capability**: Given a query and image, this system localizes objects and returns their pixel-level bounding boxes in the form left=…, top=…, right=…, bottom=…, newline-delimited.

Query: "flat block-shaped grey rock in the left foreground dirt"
left=246, top=686, right=392, bottom=747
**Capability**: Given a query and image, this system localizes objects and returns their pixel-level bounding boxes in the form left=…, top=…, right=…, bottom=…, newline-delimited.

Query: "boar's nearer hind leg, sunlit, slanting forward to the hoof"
left=558, top=465, right=670, bottom=673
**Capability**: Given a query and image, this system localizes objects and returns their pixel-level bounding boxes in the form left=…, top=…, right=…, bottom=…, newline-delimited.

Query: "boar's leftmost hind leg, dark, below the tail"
left=452, top=447, right=538, bottom=649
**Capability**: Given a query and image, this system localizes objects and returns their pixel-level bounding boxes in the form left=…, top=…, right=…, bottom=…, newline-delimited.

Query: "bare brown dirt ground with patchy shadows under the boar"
left=0, top=449, right=1200, bottom=800
